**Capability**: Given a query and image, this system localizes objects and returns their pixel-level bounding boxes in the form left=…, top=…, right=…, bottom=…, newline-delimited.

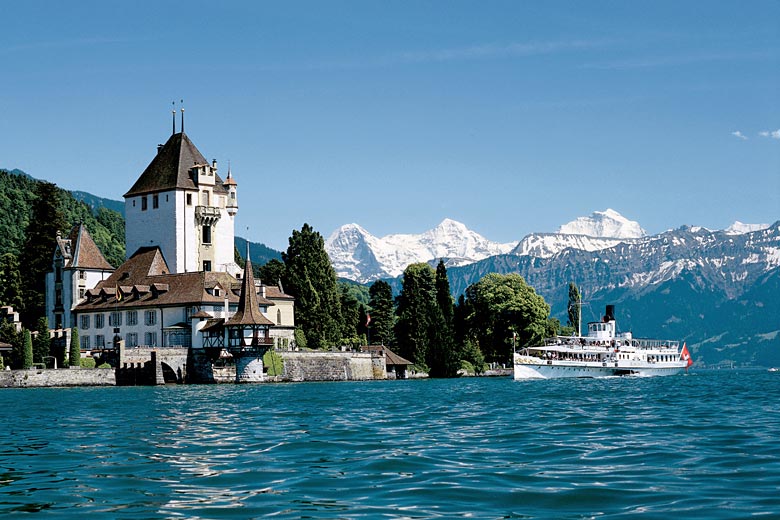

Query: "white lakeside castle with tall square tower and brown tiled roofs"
left=46, top=129, right=295, bottom=372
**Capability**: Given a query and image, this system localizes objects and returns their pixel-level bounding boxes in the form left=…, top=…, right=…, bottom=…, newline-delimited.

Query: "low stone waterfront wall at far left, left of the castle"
left=0, top=368, right=116, bottom=388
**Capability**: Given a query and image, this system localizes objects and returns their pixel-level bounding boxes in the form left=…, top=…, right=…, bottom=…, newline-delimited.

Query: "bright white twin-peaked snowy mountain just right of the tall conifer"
left=325, top=219, right=516, bottom=282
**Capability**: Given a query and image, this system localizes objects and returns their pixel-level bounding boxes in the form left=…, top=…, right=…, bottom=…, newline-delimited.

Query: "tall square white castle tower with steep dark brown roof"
left=124, top=132, right=241, bottom=276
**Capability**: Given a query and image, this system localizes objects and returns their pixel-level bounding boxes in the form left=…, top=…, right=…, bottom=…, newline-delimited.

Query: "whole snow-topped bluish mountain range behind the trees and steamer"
left=326, top=210, right=780, bottom=365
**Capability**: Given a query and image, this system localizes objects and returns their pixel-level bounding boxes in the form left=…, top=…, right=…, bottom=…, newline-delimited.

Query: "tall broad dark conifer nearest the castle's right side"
left=282, top=224, right=341, bottom=348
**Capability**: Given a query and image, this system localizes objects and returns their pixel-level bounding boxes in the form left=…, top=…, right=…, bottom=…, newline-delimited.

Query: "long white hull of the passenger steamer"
left=514, top=358, right=685, bottom=380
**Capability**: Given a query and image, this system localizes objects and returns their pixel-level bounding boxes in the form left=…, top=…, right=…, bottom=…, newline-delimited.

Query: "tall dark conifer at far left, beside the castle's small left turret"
left=20, top=182, right=67, bottom=328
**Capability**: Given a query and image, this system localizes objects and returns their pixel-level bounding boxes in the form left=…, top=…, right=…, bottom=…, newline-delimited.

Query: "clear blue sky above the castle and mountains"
left=0, top=1, right=780, bottom=249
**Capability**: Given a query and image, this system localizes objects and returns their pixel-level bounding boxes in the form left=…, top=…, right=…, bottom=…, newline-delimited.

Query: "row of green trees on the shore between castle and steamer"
left=257, top=224, right=573, bottom=377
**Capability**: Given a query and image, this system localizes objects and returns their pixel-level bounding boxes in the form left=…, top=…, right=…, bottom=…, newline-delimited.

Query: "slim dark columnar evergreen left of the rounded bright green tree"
left=428, top=260, right=459, bottom=377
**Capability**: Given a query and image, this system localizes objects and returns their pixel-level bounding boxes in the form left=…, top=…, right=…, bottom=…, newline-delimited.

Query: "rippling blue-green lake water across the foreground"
left=0, top=371, right=780, bottom=520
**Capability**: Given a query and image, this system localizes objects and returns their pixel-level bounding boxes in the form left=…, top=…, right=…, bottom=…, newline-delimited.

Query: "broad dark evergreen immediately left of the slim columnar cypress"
left=395, top=263, right=441, bottom=371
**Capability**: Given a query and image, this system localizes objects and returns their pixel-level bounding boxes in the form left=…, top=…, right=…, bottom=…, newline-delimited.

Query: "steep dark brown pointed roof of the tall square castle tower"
left=124, top=132, right=226, bottom=198
